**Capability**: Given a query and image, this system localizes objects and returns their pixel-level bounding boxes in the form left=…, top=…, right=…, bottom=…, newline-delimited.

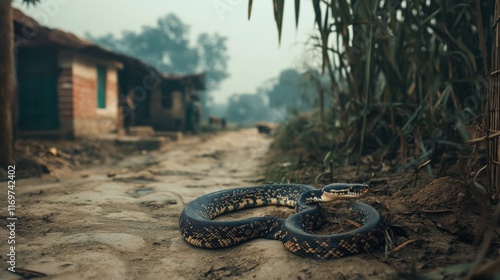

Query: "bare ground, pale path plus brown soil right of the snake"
left=0, top=129, right=500, bottom=280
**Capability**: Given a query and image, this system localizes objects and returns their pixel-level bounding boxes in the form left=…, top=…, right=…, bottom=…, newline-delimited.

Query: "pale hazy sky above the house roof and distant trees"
left=14, top=0, right=314, bottom=102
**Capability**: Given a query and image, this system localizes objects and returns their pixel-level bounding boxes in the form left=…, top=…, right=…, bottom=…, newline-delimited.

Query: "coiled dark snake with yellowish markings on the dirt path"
left=179, top=183, right=384, bottom=259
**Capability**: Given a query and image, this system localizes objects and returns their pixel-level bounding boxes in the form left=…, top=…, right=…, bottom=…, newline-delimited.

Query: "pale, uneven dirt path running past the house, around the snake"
left=0, top=130, right=392, bottom=280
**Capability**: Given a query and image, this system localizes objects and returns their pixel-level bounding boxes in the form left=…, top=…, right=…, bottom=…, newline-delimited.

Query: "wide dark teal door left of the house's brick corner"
left=17, top=50, right=59, bottom=130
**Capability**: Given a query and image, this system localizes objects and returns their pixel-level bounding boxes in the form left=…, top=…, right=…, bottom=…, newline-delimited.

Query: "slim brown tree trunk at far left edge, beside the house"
left=0, top=0, right=39, bottom=168
